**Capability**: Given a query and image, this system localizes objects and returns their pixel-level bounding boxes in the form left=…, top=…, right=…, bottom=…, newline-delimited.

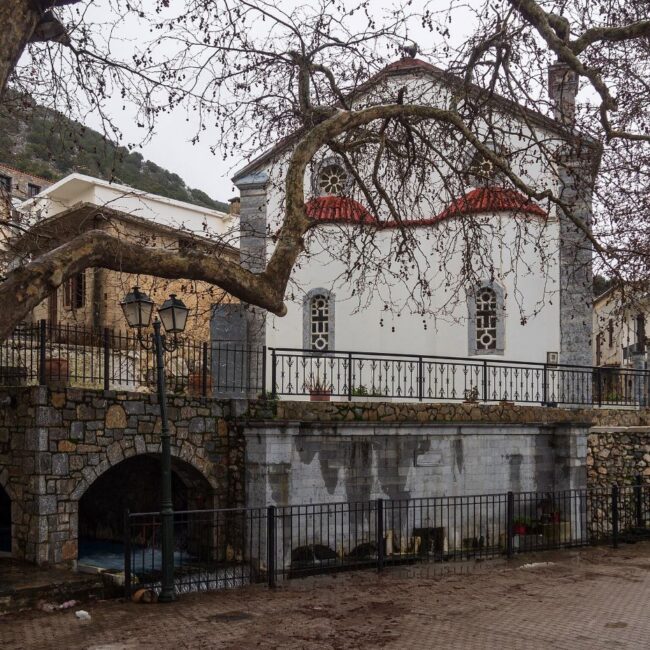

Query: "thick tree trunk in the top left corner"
left=0, top=0, right=41, bottom=97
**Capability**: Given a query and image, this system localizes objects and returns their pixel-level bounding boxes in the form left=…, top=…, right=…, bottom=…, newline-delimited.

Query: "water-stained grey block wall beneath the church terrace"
left=244, top=422, right=588, bottom=506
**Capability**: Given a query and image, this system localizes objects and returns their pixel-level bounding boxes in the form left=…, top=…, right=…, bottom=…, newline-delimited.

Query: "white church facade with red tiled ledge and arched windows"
left=212, top=58, right=592, bottom=394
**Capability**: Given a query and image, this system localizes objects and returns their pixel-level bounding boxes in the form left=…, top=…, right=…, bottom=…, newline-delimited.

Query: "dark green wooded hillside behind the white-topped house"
left=0, top=98, right=228, bottom=212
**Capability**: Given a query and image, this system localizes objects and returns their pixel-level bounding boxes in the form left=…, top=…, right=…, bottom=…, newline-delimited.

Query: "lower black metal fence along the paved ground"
left=124, top=477, right=650, bottom=594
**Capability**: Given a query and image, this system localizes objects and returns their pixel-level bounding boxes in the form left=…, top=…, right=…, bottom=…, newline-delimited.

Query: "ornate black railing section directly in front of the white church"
left=264, top=348, right=650, bottom=406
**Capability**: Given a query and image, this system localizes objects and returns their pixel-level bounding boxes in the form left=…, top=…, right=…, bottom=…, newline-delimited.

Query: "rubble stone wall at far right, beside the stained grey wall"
left=586, top=426, right=650, bottom=488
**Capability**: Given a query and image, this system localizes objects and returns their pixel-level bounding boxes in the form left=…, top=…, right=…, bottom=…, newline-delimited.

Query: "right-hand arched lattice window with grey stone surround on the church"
left=468, top=282, right=505, bottom=354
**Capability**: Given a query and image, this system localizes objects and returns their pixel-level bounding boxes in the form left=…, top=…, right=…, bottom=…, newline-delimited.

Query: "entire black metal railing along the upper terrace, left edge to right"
left=0, top=321, right=650, bottom=407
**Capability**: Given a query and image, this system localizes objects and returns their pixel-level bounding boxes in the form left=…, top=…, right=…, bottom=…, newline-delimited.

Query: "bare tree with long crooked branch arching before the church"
left=0, top=0, right=650, bottom=336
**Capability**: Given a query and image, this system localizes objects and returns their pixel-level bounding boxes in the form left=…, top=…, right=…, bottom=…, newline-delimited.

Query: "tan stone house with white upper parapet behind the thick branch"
left=20, top=174, right=238, bottom=341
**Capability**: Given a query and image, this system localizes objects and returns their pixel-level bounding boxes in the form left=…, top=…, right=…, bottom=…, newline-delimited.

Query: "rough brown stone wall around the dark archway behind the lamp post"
left=0, top=387, right=244, bottom=564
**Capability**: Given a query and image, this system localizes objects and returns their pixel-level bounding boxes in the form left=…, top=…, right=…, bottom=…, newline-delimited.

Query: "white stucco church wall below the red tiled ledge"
left=267, top=213, right=560, bottom=362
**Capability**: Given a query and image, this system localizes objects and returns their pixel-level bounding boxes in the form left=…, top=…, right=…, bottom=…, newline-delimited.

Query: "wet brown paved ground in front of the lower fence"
left=0, top=543, right=650, bottom=650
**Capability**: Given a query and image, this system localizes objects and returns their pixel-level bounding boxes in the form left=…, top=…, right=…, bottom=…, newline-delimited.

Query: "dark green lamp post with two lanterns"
left=120, top=287, right=190, bottom=603
